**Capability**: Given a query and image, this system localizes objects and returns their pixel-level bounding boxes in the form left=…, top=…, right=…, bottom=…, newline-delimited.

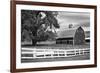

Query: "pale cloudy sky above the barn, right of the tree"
left=57, top=11, right=90, bottom=31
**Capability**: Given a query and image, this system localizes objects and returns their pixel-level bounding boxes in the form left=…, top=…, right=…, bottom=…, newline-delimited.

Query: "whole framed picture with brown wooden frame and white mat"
left=11, top=1, right=97, bottom=72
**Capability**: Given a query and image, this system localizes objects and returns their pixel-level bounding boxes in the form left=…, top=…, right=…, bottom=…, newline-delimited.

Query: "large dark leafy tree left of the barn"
left=21, top=10, right=59, bottom=45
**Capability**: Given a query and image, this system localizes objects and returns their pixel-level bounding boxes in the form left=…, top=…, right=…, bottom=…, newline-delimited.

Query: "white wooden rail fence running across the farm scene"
left=21, top=48, right=90, bottom=59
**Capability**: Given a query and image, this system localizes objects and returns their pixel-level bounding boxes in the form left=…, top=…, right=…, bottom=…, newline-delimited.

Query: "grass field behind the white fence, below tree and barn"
left=22, top=42, right=90, bottom=49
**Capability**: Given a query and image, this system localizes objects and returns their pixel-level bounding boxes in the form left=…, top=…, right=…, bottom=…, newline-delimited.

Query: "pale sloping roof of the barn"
left=57, top=28, right=78, bottom=38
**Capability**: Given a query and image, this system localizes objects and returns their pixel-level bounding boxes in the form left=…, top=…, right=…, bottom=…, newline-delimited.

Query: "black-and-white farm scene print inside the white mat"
left=21, top=10, right=91, bottom=63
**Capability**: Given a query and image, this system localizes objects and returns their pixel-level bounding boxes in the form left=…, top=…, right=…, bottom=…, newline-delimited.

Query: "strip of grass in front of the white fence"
left=21, top=53, right=90, bottom=63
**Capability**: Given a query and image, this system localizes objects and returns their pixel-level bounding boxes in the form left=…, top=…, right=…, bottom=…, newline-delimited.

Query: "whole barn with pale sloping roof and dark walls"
left=56, top=26, right=85, bottom=45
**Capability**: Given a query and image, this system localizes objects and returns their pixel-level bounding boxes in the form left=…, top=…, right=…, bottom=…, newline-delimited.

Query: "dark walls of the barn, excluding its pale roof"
left=56, top=27, right=85, bottom=45
